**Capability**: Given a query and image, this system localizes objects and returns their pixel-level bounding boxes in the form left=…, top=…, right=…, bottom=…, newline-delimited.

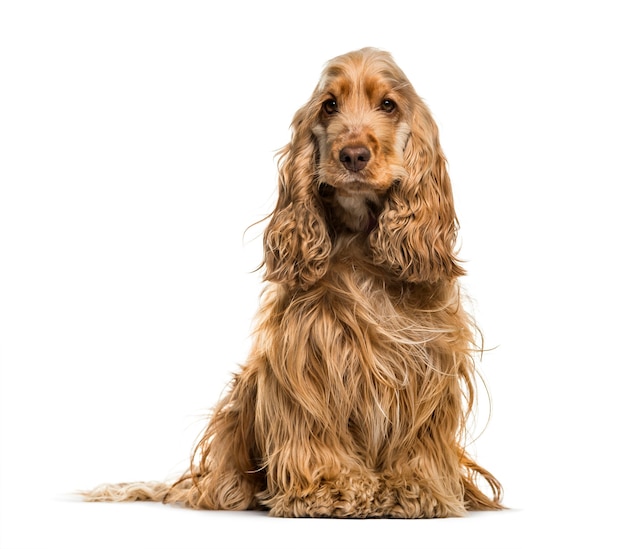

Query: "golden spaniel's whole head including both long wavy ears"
left=264, top=48, right=464, bottom=288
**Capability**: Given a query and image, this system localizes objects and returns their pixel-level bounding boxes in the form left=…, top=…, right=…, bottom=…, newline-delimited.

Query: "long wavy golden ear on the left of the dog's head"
left=263, top=102, right=331, bottom=289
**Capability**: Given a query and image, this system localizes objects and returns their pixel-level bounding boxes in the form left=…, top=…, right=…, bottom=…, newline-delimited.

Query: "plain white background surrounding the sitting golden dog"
left=0, top=0, right=626, bottom=549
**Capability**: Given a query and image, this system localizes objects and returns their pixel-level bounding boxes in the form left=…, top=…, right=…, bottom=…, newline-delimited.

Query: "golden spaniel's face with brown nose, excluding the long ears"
left=313, top=50, right=414, bottom=222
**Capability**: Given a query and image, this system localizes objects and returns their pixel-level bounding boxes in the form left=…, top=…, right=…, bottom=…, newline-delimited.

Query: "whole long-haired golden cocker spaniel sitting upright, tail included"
left=86, top=48, right=501, bottom=518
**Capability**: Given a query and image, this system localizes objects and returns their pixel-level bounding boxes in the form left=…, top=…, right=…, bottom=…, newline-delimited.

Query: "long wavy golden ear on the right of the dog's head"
left=370, top=99, right=465, bottom=283
